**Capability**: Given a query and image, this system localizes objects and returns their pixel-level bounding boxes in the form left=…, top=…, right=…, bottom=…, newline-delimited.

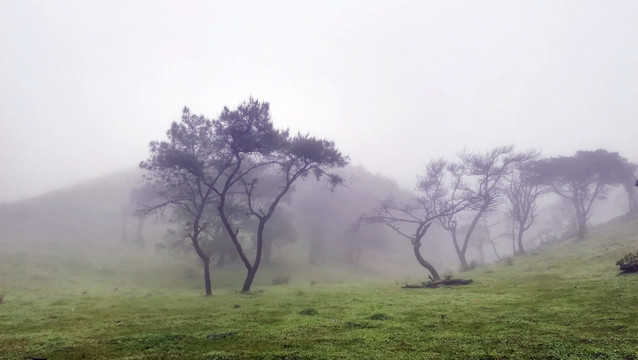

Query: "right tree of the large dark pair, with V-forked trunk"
left=212, top=98, right=348, bottom=292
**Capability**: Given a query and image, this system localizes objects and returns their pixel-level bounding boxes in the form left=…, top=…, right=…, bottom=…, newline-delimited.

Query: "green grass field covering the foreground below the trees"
left=0, top=220, right=638, bottom=359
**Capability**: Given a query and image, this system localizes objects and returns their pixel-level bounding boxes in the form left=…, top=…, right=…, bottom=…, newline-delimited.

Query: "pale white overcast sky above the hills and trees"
left=0, top=0, right=638, bottom=201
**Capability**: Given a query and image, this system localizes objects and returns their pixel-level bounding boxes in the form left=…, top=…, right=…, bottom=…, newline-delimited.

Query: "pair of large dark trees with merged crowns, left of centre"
left=140, top=98, right=348, bottom=294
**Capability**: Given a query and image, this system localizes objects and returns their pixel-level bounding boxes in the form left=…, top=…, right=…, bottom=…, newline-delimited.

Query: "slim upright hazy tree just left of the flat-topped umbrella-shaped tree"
left=505, top=151, right=547, bottom=254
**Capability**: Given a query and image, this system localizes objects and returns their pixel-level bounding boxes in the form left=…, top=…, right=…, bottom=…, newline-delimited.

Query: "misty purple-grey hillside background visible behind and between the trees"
left=0, top=153, right=629, bottom=292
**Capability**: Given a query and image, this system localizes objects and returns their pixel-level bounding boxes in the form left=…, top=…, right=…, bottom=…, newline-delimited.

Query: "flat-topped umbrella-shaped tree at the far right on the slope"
left=531, top=149, right=634, bottom=239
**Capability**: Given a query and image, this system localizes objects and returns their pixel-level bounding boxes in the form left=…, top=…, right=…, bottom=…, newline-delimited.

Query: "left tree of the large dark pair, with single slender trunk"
left=138, top=108, right=218, bottom=296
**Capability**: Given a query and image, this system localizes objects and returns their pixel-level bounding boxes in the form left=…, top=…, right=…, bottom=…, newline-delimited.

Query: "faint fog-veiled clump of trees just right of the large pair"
left=288, top=166, right=404, bottom=266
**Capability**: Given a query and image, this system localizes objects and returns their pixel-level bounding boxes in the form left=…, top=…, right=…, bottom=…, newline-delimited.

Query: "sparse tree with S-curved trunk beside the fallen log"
left=370, top=159, right=469, bottom=281
